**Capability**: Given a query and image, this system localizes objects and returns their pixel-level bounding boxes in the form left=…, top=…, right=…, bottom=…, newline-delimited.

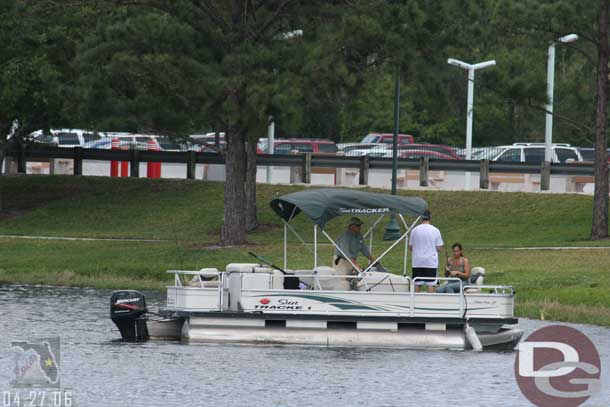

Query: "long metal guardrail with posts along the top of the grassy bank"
left=5, top=145, right=594, bottom=189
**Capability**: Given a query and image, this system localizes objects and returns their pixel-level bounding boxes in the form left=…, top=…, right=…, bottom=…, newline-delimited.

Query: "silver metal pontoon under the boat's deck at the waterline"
left=171, top=315, right=523, bottom=350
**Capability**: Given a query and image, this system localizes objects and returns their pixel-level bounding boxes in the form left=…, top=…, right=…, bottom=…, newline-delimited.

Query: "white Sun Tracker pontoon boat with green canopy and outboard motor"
left=110, top=188, right=523, bottom=350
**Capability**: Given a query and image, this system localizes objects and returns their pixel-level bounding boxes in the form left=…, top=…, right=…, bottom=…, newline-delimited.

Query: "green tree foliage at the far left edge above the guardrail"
left=0, top=0, right=79, bottom=186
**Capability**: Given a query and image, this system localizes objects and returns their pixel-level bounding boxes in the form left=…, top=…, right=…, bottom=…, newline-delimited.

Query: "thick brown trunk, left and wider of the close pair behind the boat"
left=220, top=127, right=246, bottom=246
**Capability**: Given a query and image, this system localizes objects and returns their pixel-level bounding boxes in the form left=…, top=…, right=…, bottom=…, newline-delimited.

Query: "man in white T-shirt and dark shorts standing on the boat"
left=409, top=209, right=443, bottom=293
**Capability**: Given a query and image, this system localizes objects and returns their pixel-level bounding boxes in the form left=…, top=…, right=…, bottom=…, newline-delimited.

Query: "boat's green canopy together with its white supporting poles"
left=270, top=188, right=428, bottom=276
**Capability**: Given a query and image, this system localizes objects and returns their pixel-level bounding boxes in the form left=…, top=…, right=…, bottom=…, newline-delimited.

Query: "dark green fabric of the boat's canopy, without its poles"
left=270, top=188, right=428, bottom=228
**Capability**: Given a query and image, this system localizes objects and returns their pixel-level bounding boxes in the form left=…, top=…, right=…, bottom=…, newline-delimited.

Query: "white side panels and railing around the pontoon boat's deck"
left=167, top=270, right=515, bottom=318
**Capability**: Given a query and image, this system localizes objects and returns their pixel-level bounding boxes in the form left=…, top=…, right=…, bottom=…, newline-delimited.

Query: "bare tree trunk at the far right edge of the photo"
left=591, top=0, right=610, bottom=240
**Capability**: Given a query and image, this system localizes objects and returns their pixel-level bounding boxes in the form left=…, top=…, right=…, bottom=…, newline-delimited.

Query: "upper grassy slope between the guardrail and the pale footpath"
left=0, top=176, right=610, bottom=247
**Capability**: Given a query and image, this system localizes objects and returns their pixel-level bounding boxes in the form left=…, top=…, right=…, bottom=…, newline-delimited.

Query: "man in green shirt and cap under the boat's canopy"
left=333, top=218, right=375, bottom=275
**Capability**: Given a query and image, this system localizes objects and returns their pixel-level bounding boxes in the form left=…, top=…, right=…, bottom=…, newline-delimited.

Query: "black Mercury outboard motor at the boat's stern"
left=110, top=290, right=148, bottom=341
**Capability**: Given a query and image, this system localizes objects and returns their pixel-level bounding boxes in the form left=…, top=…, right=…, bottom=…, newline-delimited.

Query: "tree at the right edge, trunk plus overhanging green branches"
left=492, top=0, right=610, bottom=240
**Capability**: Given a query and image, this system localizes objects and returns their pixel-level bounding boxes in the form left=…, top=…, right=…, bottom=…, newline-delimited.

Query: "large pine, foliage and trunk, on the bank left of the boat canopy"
left=65, top=0, right=295, bottom=245
